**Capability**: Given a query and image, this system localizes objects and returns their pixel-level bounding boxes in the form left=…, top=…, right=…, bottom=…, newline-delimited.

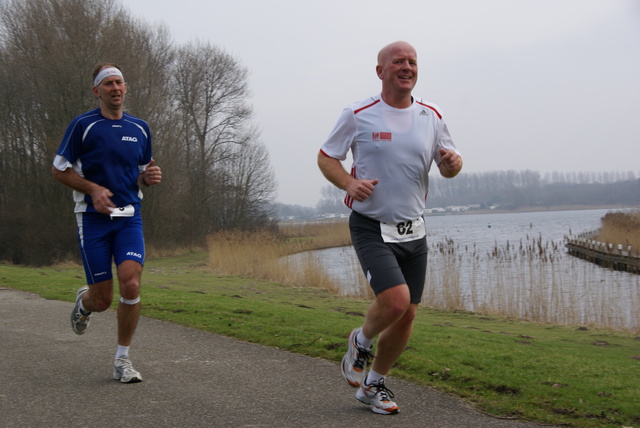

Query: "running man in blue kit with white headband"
left=52, top=64, right=162, bottom=383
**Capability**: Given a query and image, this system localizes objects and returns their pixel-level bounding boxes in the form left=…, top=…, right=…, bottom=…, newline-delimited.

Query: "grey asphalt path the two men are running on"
left=0, top=288, right=535, bottom=428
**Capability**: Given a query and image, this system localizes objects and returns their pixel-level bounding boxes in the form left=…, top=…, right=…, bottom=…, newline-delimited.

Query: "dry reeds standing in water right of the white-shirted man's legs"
left=423, top=236, right=640, bottom=332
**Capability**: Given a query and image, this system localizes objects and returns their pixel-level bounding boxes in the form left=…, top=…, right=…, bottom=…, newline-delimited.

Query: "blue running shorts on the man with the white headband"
left=76, top=205, right=145, bottom=284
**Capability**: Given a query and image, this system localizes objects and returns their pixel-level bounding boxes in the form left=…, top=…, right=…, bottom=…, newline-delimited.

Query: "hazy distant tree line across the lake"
left=292, top=169, right=640, bottom=218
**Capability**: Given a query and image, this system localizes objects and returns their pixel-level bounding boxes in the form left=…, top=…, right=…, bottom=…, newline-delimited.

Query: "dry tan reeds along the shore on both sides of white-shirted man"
left=208, top=216, right=640, bottom=332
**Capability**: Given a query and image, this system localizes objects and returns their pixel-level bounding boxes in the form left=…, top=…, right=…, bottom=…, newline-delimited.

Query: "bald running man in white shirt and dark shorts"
left=318, top=42, right=462, bottom=414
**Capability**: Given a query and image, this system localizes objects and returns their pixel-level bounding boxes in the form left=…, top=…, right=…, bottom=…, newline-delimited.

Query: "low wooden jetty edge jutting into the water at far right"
left=565, top=230, right=640, bottom=274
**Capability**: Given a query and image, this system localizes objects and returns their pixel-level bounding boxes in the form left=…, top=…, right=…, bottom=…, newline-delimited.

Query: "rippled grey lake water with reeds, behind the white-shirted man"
left=290, top=210, right=640, bottom=331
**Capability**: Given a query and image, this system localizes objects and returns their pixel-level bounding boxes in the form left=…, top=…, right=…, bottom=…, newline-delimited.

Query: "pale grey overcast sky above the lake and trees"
left=123, top=0, right=640, bottom=206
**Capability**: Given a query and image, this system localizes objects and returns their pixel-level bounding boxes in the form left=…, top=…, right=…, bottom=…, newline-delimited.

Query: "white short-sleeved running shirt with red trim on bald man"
left=321, top=95, right=459, bottom=223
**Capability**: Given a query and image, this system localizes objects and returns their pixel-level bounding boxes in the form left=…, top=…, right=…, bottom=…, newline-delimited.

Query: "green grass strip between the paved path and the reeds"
left=0, top=253, right=640, bottom=427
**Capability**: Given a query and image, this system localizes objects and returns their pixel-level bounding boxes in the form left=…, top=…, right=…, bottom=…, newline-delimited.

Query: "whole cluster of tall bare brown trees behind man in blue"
left=0, top=0, right=276, bottom=265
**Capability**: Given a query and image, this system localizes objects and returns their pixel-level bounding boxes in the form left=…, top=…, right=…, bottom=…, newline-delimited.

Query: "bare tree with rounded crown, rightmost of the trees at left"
left=169, top=43, right=273, bottom=239
